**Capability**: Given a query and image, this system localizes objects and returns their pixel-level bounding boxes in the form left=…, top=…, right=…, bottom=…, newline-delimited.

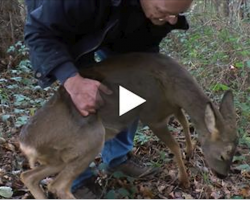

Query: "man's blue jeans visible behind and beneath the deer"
left=72, top=50, right=138, bottom=191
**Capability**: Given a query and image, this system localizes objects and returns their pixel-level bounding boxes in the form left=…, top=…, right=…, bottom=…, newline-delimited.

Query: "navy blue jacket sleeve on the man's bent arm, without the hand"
left=25, top=0, right=94, bottom=87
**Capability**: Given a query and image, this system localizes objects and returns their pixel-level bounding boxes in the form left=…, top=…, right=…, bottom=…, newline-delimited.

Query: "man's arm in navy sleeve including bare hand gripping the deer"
left=25, top=0, right=110, bottom=116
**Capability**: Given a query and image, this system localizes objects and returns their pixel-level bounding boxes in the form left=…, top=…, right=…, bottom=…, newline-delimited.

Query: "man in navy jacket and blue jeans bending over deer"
left=25, top=0, right=192, bottom=198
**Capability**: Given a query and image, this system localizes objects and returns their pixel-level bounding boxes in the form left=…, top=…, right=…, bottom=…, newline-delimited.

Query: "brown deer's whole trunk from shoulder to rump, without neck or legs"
left=20, top=53, right=206, bottom=154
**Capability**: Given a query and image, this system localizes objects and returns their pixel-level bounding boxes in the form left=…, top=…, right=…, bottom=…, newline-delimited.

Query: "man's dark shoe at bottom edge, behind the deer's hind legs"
left=73, top=177, right=102, bottom=199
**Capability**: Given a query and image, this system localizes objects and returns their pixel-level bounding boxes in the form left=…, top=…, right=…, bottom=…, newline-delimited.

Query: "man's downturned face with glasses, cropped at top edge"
left=140, top=0, right=192, bottom=25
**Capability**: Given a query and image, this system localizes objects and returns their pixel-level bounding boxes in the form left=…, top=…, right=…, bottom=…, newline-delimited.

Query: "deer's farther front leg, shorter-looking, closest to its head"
left=175, top=109, right=194, bottom=158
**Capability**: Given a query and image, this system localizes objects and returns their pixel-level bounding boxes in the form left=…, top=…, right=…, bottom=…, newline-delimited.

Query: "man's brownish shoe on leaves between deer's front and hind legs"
left=107, top=153, right=159, bottom=178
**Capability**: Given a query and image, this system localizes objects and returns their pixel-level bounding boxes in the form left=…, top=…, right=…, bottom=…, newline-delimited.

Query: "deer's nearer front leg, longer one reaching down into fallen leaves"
left=150, top=123, right=190, bottom=188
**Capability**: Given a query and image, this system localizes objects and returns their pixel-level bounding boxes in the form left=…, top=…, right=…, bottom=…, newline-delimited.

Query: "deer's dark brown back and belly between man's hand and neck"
left=81, top=53, right=206, bottom=128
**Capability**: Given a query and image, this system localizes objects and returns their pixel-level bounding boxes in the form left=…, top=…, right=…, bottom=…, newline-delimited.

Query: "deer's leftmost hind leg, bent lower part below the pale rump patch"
left=21, top=165, right=63, bottom=199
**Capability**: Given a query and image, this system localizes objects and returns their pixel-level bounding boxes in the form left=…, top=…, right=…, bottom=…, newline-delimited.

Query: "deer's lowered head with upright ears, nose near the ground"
left=200, top=91, right=238, bottom=178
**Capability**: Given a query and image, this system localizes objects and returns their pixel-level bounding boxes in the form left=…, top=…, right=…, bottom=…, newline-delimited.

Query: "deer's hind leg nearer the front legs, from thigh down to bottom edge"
left=49, top=123, right=105, bottom=199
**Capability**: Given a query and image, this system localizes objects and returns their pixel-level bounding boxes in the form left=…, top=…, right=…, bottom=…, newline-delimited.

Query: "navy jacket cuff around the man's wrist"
left=50, top=62, right=78, bottom=85
